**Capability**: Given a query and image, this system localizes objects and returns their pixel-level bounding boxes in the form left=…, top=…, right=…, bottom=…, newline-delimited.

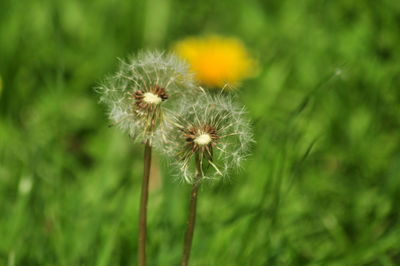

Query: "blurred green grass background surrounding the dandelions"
left=0, top=0, right=400, bottom=266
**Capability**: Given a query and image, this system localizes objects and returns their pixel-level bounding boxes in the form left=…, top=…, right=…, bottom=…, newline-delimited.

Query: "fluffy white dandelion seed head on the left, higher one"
left=97, top=52, right=197, bottom=142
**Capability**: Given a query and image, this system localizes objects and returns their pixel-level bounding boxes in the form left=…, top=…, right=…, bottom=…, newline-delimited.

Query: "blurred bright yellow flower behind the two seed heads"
left=175, top=36, right=255, bottom=87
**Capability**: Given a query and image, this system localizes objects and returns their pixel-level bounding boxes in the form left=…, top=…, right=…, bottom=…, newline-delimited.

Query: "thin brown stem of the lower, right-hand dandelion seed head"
left=182, top=153, right=202, bottom=266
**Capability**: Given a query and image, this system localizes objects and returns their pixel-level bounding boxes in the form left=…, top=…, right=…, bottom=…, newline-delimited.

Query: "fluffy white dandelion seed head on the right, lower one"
left=164, top=92, right=253, bottom=183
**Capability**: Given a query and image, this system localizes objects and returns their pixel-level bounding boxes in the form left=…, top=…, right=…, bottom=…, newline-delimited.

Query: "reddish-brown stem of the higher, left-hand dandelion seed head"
left=138, top=141, right=151, bottom=266
